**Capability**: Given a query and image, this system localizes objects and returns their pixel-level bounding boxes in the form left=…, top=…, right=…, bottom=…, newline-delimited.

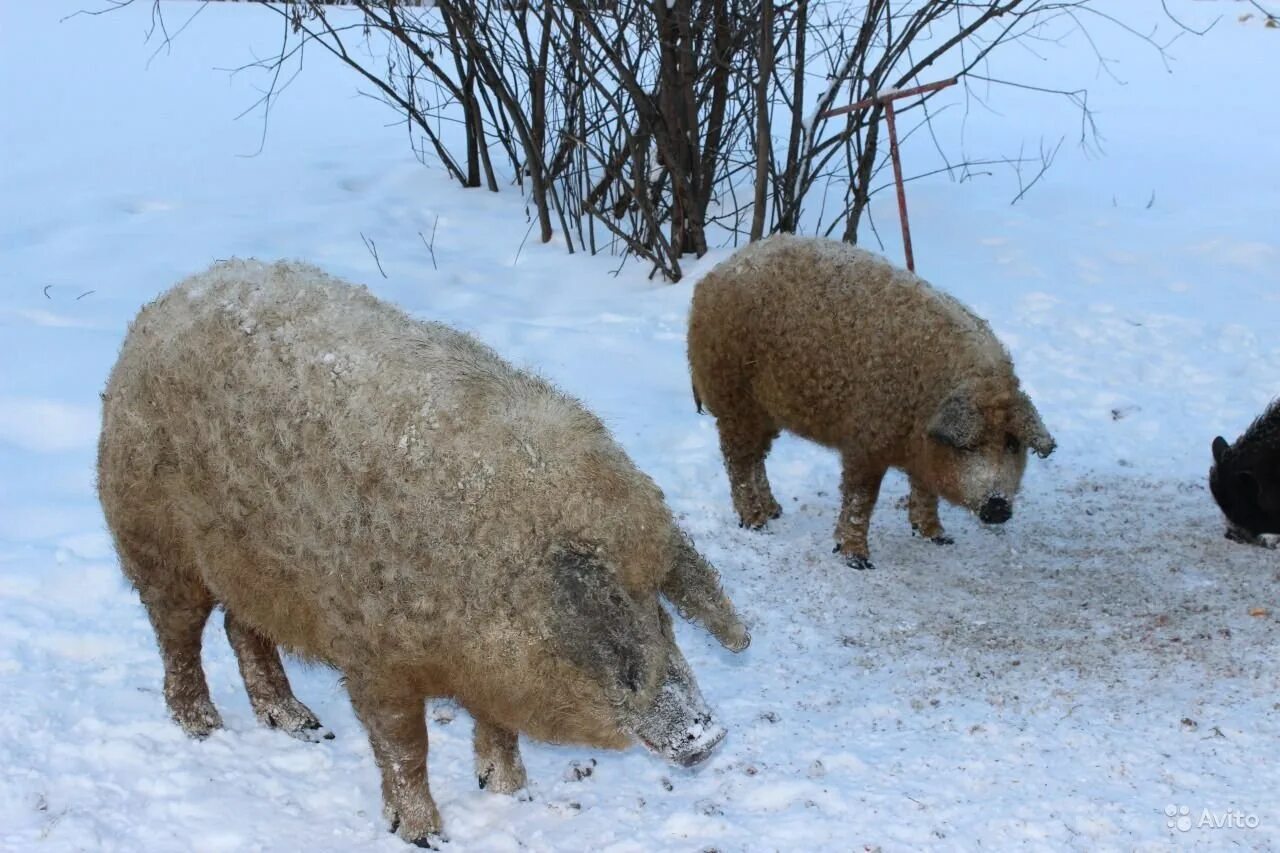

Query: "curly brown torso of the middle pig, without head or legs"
left=690, top=234, right=1012, bottom=450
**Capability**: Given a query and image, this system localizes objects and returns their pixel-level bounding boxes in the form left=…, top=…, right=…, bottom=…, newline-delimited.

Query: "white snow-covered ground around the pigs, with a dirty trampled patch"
left=0, top=0, right=1280, bottom=850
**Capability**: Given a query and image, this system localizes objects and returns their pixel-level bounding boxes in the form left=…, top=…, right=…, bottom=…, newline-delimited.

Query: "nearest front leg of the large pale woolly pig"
left=347, top=679, right=447, bottom=849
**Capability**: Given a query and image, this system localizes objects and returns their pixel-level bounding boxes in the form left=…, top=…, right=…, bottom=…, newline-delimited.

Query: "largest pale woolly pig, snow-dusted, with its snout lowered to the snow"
left=99, top=261, right=749, bottom=843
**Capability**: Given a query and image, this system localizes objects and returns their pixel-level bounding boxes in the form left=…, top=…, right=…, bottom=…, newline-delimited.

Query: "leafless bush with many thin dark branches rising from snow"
left=113, top=0, right=1180, bottom=280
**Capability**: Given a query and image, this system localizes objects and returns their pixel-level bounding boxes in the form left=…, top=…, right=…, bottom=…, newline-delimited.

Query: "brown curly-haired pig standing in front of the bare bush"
left=689, top=234, right=1053, bottom=569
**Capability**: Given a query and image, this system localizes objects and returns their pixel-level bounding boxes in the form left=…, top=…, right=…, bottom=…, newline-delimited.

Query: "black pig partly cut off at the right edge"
left=1208, top=400, right=1280, bottom=546
